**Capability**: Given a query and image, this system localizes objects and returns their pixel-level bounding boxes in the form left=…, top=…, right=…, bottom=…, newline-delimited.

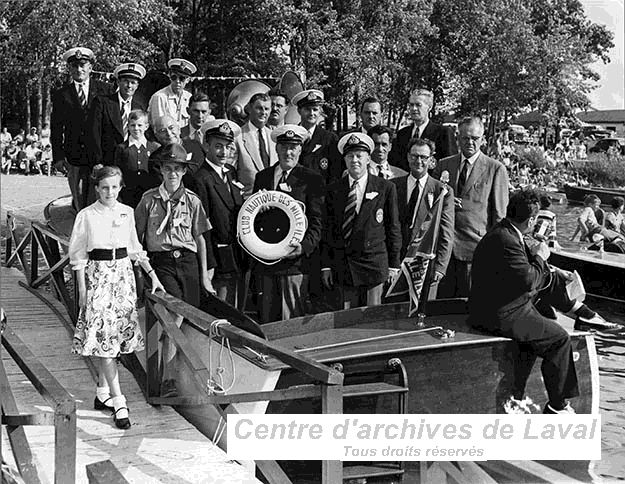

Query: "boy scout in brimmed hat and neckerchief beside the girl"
left=135, top=143, right=213, bottom=396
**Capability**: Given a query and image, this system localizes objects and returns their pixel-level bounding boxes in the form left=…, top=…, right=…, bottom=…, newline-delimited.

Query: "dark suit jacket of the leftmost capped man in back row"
left=50, top=79, right=112, bottom=165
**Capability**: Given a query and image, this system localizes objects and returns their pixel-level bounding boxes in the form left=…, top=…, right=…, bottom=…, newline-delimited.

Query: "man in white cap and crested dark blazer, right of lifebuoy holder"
left=321, top=133, right=401, bottom=309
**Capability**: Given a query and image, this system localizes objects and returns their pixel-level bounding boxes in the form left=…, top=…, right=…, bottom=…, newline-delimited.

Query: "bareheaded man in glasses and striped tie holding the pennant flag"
left=391, top=134, right=454, bottom=299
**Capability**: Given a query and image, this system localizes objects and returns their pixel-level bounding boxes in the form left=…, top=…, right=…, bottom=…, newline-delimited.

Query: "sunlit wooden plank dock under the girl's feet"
left=0, top=267, right=259, bottom=484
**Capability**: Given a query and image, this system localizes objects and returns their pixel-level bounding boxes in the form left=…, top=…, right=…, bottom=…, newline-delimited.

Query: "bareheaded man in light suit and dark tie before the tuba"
left=237, top=93, right=278, bottom=198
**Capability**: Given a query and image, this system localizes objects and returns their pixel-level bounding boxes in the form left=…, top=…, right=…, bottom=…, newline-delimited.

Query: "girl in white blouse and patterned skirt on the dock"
left=69, top=166, right=163, bottom=429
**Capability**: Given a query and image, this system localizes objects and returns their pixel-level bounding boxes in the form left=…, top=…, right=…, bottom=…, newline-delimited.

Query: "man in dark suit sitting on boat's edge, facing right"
left=468, top=190, right=604, bottom=413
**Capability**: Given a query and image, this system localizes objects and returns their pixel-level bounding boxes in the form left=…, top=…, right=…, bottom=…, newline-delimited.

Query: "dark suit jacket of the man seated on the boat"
left=469, top=219, right=549, bottom=337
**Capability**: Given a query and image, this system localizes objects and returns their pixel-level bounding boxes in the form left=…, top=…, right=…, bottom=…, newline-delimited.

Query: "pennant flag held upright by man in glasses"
left=386, top=189, right=447, bottom=316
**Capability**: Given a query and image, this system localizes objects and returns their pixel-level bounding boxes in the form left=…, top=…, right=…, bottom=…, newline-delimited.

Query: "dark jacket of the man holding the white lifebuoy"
left=254, top=165, right=324, bottom=275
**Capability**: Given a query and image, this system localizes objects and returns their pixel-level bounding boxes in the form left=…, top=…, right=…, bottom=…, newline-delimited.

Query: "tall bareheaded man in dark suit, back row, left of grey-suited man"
left=390, top=89, right=458, bottom=171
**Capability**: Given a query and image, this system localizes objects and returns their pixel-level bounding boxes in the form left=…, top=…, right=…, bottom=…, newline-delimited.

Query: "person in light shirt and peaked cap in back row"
left=148, top=59, right=197, bottom=128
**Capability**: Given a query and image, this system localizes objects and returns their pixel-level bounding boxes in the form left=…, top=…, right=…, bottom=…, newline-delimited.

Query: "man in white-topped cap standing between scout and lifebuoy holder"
left=194, top=119, right=245, bottom=308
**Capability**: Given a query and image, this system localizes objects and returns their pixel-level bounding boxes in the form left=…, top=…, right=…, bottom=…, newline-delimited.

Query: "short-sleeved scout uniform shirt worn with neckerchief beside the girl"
left=135, top=184, right=211, bottom=253
